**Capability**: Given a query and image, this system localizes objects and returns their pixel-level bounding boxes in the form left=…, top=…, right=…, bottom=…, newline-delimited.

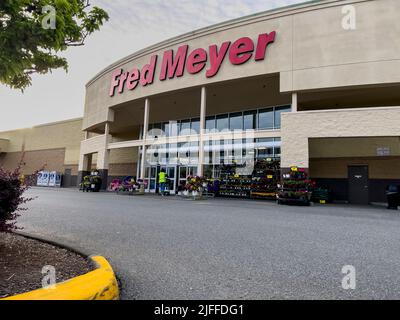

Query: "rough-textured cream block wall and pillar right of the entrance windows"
left=281, top=107, right=400, bottom=168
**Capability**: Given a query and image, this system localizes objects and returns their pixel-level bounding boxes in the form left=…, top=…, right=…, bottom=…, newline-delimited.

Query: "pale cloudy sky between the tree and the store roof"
left=0, top=0, right=304, bottom=131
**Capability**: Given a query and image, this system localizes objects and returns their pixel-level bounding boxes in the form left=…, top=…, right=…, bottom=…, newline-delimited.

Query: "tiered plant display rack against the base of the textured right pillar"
left=277, top=167, right=315, bottom=205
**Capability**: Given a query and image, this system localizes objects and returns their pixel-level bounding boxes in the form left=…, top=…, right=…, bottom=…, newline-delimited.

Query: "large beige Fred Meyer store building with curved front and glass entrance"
left=0, top=0, right=400, bottom=204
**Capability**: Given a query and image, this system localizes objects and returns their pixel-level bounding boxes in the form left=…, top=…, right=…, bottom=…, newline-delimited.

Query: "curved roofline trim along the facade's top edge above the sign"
left=86, top=0, right=372, bottom=87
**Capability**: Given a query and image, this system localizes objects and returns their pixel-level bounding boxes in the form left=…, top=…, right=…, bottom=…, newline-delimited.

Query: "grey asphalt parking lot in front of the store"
left=19, top=188, right=400, bottom=300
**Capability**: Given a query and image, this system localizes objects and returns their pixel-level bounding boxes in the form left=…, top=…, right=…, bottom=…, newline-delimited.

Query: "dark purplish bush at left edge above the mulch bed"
left=0, top=165, right=32, bottom=232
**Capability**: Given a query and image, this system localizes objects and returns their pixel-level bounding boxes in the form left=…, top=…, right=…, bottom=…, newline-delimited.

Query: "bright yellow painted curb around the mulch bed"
left=0, top=256, right=119, bottom=300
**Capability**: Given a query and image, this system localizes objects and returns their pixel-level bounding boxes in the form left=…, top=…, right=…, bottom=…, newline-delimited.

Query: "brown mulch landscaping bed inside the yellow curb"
left=0, top=232, right=95, bottom=299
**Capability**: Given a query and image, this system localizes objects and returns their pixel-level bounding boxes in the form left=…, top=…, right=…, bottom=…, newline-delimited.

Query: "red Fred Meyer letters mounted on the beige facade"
left=109, top=31, right=276, bottom=97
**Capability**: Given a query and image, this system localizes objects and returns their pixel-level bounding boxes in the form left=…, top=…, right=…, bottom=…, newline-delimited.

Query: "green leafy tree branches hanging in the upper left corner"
left=0, top=0, right=109, bottom=90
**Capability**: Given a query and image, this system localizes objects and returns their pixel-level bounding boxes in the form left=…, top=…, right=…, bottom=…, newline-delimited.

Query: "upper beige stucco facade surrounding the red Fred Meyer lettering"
left=83, top=0, right=400, bottom=128
